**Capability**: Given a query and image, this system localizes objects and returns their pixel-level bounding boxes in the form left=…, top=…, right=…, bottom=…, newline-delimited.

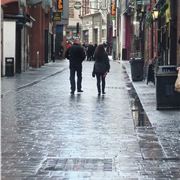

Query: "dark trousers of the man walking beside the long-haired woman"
left=70, top=65, right=82, bottom=92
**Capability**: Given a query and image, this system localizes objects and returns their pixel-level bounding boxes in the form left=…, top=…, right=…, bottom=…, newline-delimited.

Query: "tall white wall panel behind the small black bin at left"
left=3, top=21, right=16, bottom=75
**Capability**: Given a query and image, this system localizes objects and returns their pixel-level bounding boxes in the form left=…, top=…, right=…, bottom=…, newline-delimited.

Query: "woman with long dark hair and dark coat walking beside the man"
left=92, top=44, right=110, bottom=95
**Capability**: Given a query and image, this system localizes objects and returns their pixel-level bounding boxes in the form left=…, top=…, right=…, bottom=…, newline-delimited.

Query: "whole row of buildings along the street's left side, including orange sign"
left=1, top=0, right=69, bottom=76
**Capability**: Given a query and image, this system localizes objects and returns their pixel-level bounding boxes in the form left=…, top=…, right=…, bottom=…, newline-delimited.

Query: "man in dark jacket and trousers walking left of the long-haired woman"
left=65, top=39, right=86, bottom=95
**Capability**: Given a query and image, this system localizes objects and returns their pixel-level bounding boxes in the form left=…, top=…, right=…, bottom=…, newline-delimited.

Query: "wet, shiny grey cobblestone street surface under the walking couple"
left=1, top=61, right=180, bottom=180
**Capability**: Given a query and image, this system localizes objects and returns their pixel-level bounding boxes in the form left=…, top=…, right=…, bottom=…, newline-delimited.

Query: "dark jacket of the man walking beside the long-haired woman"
left=65, top=44, right=86, bottom=68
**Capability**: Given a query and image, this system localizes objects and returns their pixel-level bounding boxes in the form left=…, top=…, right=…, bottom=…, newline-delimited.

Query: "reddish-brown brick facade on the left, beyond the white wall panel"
left=28, top=1, right=53, bottom=67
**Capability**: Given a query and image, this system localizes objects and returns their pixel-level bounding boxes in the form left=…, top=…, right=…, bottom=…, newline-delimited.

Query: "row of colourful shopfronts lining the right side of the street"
left=117, top=0, right=180, bottom=65
